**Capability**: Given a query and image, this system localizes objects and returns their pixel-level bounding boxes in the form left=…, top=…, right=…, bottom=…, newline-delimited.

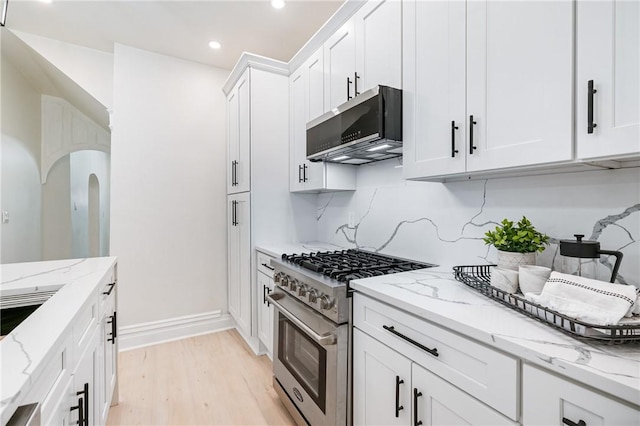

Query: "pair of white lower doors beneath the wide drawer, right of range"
left=353, top=329, right=516, bottom=426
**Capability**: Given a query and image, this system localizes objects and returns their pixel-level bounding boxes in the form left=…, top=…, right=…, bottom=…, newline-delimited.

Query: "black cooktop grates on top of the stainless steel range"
left=282, top=249, right=436, bottom=282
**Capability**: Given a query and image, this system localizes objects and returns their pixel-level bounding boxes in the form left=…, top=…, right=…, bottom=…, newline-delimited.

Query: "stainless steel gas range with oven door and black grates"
left=268, top=249, right=436, bottom=426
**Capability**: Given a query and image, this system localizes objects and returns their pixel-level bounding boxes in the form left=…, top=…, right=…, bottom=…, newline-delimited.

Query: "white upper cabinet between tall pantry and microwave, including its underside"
left=289, top=48, right=356, bottom=192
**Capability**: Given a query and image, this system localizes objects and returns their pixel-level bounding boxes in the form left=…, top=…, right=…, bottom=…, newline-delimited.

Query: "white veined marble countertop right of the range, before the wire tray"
left=350, top=267, right=640, bottom=407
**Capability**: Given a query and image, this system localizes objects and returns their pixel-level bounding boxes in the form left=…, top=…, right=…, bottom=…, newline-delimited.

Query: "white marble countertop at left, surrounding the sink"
left=0, top=257, right=116, bottom=424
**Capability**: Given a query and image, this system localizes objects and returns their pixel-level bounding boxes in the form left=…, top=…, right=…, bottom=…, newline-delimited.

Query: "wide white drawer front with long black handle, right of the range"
left=353, top=294, right=520, bottom=420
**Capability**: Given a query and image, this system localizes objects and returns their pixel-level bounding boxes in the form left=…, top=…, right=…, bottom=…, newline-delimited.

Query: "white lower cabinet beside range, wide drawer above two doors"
left=353, top=293, right=519, bottom=425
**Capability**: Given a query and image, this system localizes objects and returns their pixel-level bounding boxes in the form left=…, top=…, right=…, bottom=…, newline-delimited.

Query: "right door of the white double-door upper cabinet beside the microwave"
left=466, top=1, right=574, bottom=171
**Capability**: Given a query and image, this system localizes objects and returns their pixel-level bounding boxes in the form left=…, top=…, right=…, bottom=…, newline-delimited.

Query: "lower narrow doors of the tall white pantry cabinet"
left=227, top=192, right=251, bottom=335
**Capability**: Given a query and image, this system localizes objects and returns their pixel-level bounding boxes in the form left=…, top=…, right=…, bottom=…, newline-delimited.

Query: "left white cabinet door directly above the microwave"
left=324, top=18, right=356, bottom=111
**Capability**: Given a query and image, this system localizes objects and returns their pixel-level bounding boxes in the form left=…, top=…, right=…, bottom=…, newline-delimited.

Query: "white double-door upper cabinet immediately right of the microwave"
left=403, top=1, right=574, bottom=179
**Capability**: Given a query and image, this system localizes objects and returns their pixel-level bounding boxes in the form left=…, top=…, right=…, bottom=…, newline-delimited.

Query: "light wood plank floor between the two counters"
left=107, top=330, right=295, bottom=425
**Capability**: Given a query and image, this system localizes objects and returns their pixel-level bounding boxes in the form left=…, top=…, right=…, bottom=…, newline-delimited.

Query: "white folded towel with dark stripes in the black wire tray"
left=525, top=271, right=640, bottom=325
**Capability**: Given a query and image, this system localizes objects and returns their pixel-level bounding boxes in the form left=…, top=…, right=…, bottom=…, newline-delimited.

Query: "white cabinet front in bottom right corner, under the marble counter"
left=522, top=365, right=640, bottom=426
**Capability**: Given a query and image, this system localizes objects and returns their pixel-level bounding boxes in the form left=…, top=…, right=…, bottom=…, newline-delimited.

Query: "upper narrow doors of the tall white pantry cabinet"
left=227, top=68, right=251, bottom=194
